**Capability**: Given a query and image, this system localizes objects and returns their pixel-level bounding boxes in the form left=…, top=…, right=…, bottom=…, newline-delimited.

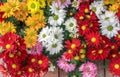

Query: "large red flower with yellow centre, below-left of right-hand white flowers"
left=85, top=32, right=102, bottom=47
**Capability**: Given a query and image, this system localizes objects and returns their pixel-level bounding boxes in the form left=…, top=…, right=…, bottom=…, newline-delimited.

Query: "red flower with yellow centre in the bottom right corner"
left=109, top=59, right=120, bottom=76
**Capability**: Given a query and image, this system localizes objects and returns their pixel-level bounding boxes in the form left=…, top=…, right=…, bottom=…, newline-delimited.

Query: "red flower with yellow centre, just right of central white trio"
left=65, top=38, right=81, bottom=51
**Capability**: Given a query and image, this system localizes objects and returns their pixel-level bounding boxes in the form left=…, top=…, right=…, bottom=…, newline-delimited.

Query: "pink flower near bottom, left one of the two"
left=57, top=58, right=76, bottom=72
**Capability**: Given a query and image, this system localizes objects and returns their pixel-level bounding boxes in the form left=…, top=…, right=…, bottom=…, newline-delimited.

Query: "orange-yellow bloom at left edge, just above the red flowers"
left=0, top=22, right=16, bottom=35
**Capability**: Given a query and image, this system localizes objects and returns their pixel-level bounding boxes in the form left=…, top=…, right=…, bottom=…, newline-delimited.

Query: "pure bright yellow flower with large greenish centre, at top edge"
left=27, top=0, right=40, bottom=14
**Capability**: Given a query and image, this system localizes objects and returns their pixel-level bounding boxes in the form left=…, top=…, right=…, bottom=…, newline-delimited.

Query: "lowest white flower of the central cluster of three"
left=45, top=40, right=63, bottom=55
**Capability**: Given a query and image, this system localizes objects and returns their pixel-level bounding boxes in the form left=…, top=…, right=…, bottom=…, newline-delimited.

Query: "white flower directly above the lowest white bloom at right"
left=99, top=11, right=117, bottom=23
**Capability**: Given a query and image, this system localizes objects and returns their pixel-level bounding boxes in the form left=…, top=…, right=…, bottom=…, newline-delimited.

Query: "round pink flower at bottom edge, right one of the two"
left=79, top=62, right=97, bottom=77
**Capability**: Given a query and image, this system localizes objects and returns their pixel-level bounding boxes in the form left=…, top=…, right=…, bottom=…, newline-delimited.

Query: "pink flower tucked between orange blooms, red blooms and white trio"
left=28, top=42, right=43, bottom=55
